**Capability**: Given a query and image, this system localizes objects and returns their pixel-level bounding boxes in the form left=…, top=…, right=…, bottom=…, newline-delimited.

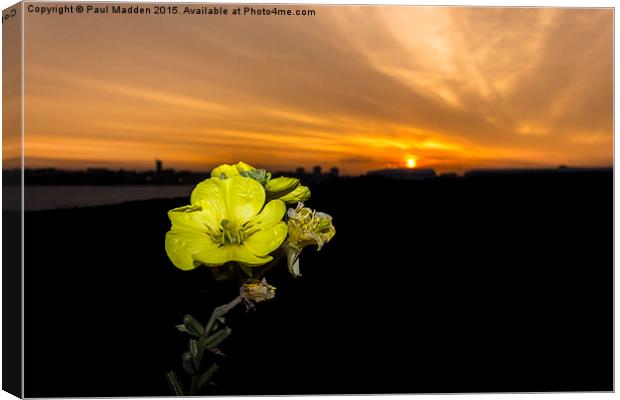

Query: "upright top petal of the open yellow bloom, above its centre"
left=219, top=176, right=265, bottom=226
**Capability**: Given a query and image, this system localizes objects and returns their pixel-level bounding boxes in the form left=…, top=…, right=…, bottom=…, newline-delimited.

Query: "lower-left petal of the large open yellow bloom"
left=165, top=230, right=223, bottom=270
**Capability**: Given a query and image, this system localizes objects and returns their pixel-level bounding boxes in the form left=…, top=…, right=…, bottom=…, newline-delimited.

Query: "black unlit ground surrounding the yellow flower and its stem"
left=20, top=173, right=613, bottom=397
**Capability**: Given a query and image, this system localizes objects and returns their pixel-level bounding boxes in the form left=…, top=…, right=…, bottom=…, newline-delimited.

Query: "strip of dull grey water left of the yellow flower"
left=24, top=185, right=193, bottom=211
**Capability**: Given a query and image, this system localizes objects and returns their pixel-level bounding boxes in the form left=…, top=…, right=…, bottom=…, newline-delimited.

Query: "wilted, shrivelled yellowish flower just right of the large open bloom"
left=285, top=202, right=336, bottom=276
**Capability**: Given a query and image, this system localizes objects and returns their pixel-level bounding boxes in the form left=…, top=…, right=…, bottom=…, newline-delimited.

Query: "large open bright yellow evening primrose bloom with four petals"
left=166, top=175, right=288, bottom=270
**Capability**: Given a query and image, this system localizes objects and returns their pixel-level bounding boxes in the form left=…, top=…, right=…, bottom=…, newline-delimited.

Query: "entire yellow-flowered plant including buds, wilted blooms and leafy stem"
left=165, top=162, right=336, bottom=396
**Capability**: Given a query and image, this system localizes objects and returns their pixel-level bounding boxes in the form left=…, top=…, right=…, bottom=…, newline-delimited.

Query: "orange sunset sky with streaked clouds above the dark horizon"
left=25, top=6, right=613, bottom=174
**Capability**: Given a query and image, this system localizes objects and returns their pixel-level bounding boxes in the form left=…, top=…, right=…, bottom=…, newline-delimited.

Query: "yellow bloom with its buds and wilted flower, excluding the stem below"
left=165, top=162, right=335, bottom=282
